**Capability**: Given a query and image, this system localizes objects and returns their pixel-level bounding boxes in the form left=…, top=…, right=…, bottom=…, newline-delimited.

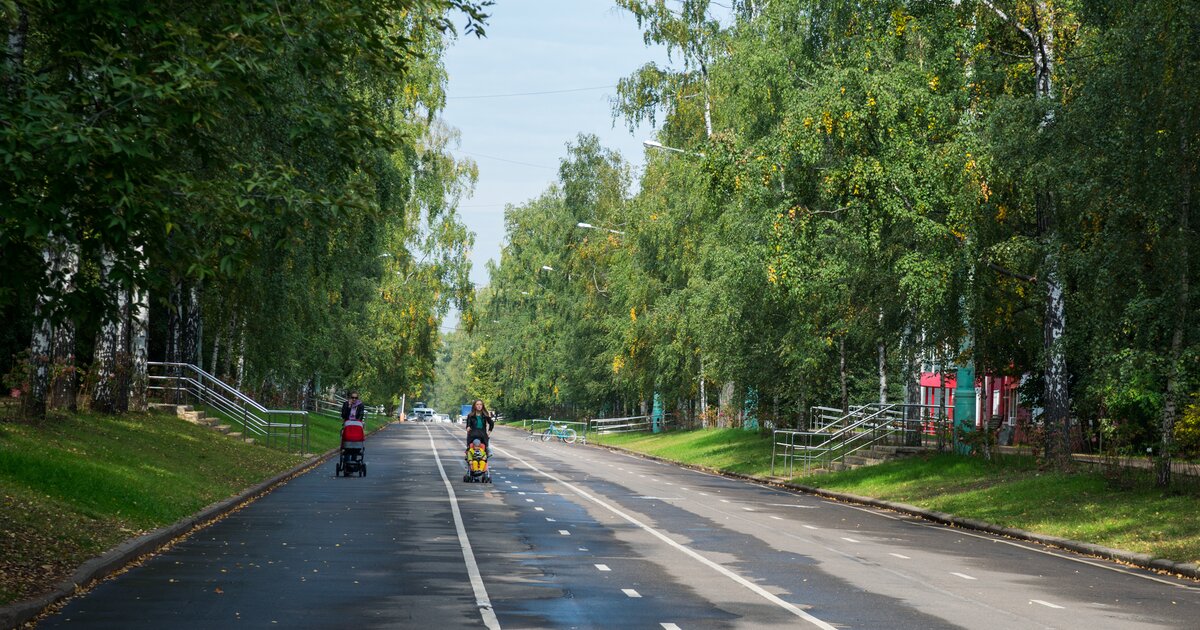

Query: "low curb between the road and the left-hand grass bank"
left=0, top=424, right=390, bottom=629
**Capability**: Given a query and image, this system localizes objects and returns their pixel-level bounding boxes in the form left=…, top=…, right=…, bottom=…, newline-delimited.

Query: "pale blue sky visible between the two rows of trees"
left=442, top=0, right=667, bottom=290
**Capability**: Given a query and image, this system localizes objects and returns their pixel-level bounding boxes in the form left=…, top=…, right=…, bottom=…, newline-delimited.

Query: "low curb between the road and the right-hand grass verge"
left=587, top=443, right=1200, bottom=580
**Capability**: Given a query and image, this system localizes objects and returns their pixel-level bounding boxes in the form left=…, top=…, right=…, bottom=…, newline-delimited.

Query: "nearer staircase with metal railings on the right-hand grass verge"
left=770, top=403, right=948, bottom=478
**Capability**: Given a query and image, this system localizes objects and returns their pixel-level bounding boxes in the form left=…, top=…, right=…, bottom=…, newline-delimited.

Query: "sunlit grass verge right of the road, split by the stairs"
left=595, top=430, right=1200, bottom=562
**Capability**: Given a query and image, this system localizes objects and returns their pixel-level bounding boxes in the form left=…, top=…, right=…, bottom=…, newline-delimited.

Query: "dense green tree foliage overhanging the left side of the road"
left=0, top=0, right=491, bottom=410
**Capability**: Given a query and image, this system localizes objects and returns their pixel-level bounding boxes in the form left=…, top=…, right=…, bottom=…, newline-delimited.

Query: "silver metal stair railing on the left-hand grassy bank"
left=146, top=361, right=308, bottom=452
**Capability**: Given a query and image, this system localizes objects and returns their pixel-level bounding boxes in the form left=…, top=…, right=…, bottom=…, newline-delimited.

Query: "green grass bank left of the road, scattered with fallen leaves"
left=0, top=413, right=301, bottom=605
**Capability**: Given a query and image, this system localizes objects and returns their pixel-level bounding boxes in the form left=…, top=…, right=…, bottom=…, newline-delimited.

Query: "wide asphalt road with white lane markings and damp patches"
left=40, top=424, right=1200, bottom=630
